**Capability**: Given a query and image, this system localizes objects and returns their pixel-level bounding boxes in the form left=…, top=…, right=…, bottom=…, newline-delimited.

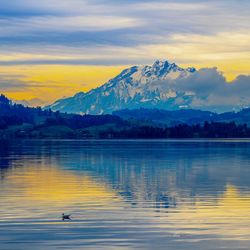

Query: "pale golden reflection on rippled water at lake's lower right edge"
left=158, top=185, right=250, bottom=240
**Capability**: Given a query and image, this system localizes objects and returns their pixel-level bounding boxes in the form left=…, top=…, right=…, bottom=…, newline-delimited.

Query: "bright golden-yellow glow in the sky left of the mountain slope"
left=0, top=65, right=124, bottom=103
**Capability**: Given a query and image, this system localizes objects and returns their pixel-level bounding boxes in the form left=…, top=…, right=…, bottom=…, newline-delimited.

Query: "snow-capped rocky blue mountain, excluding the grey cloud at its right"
left=46, top=61, right=196, bottom=114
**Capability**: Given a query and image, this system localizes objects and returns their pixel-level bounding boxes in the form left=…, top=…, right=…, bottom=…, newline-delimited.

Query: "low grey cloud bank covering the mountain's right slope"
left=174, top=68, right=250, bottom=112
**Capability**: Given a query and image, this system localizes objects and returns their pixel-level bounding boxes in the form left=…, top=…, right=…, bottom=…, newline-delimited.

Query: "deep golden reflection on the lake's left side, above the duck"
left=2, top=164, right=118, bottom=206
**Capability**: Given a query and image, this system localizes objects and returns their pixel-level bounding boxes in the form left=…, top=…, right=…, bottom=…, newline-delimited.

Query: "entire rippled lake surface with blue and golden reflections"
left=0, top=140, right=250, bottom=250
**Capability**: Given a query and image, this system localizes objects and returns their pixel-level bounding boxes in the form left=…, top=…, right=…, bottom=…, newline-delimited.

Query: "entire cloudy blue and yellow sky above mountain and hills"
left=0, top=0, right=250, bottom=103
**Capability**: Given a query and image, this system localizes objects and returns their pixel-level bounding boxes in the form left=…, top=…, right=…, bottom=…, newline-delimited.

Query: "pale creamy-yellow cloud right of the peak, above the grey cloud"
left=139, top=32, right=250, bottom=80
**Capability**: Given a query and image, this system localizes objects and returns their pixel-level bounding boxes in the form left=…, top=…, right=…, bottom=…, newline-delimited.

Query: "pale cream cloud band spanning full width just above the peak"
left=0, top=31, right=250, bottom=76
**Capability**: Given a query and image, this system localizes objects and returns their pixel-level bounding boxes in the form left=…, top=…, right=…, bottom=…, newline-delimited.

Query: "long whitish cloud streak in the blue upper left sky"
left=0, top=16, right=142, bottom=37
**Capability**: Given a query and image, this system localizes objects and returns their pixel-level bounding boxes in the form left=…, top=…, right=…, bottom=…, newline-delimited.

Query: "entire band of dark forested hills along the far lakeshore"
left=0, top=95, right=250, bottom=139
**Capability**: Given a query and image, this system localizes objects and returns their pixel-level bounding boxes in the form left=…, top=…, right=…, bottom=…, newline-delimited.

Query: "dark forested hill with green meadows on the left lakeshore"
left=0, top=95, right=126, bottom=138
